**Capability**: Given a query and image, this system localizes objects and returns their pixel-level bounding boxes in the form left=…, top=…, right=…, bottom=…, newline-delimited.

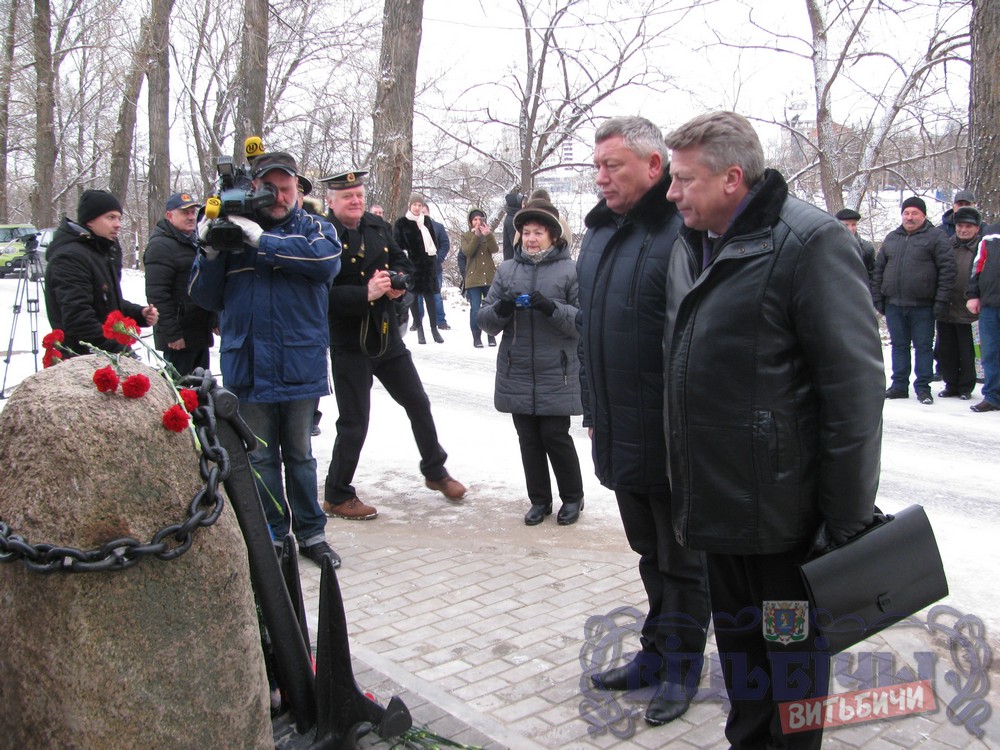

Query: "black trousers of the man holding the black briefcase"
left=707, top=551, right=830, bottom=750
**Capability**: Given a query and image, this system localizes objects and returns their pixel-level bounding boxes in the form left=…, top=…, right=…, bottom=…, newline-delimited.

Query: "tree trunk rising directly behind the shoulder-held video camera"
left=233, top=0, right=268, bottom=164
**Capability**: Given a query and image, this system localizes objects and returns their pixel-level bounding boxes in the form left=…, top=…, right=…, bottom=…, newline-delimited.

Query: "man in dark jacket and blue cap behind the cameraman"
left=142, top=193, right=216, bottom=376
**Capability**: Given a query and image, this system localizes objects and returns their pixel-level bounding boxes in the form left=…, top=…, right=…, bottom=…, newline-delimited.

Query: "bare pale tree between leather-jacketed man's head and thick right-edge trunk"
left=744, top=0, right=969, bottom=211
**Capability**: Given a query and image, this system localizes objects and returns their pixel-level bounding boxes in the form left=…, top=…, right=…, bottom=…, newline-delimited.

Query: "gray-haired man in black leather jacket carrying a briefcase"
left=664, top=112, right=884, bottom=748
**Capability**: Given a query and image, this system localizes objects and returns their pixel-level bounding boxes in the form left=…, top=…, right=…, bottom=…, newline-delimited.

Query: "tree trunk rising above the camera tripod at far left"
left=31, top=0, right=56, bottom=227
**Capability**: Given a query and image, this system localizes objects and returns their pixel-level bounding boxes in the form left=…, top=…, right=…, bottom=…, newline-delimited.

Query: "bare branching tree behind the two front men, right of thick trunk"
left=429, top=0, right=691, bottom=209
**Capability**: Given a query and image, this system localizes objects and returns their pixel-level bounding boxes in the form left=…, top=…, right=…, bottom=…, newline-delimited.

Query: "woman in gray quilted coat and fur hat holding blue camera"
left=478, top=200, right=583, bottom=526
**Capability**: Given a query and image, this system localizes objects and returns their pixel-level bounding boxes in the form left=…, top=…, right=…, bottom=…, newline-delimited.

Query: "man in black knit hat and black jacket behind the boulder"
left=45, top=190, right=159, bottom=354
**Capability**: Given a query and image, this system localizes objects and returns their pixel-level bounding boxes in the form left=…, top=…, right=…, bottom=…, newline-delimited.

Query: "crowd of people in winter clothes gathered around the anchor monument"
left=37, top=112, right=1000, bottom=748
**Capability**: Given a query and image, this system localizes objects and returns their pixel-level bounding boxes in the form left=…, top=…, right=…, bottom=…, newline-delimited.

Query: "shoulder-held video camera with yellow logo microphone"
left=204, top=136, right=278, bottom=253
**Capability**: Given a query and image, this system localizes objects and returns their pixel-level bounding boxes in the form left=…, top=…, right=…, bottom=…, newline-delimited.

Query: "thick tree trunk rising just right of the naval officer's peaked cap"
left=369, top=0, right=424, bottom=217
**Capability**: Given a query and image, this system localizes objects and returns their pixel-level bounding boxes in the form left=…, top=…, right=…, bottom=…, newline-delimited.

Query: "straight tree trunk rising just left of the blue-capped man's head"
left=148, top=0, right=174, bottom=241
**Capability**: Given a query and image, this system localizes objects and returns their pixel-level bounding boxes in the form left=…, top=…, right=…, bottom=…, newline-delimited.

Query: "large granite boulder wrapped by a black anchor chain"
left=0, top=356, right=273, bottom=748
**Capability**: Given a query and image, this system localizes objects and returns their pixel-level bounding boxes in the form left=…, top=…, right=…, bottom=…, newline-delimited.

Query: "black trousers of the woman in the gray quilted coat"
left=511, top=414, right=583, bottom=505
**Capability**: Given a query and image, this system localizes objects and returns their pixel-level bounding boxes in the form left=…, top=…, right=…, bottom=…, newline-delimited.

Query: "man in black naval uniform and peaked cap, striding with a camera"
left=323, top=171, right=465, bottom=521
